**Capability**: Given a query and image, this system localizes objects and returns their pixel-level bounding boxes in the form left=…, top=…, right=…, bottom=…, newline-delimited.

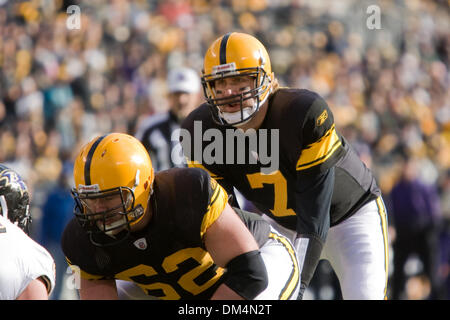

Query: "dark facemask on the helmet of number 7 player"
left=202, top=63, right=271, bottom=127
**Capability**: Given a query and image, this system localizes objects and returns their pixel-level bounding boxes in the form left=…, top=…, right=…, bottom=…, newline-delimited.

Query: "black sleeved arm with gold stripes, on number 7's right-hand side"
left=295, top=95, right=345, bottom=298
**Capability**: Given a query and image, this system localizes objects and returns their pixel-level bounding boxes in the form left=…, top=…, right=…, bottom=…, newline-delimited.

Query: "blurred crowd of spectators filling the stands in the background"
left=0, top=0, right=450, bottom=299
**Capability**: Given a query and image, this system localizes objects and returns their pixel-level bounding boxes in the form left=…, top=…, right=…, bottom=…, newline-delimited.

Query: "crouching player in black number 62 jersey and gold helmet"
left=62, top=133, right=300, bottom=300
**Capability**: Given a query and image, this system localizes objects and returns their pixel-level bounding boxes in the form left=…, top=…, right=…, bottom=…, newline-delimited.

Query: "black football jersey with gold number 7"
left=180, top=88, right=380, bottom=232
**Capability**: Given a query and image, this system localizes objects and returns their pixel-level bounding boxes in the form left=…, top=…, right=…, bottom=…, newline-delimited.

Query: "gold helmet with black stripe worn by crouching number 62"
left=72, top=133, right=154, bottom=245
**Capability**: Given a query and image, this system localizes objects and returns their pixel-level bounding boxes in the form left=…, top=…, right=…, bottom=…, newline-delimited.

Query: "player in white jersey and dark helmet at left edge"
left=0, top=164, right=55, bottom=300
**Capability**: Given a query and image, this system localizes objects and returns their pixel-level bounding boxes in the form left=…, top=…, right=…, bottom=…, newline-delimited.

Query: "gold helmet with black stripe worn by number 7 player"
left=202, top=32, right=274, bottom=126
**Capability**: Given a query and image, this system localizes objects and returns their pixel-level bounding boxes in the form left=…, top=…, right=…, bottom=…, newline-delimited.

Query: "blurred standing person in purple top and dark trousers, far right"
left=390, top=158, right=442, bottom=299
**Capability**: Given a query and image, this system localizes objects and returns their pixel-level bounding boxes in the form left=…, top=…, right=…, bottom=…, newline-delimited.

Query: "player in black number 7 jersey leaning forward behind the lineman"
left=180, top=32, right=388, bottom=299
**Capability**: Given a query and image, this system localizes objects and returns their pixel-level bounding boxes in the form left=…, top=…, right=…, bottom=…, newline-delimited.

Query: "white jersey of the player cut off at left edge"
left=0, top=216, right=55, bottom=300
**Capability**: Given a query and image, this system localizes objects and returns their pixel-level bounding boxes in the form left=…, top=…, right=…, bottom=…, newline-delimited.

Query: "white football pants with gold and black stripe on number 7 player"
left=264, top=197, right=389, bottom=300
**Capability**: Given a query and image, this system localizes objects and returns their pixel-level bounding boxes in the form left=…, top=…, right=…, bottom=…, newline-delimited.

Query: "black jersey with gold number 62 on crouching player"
left=62, top=168, right=270, bottom=300
